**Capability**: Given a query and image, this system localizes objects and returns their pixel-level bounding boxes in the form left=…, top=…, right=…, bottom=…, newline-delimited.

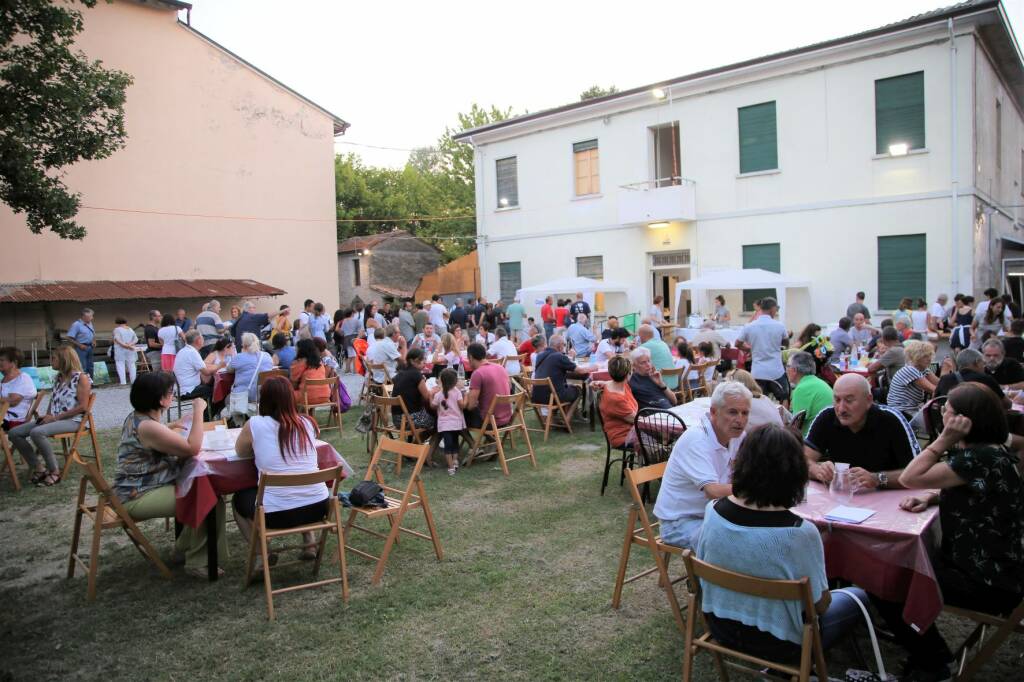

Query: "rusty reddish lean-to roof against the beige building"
left=0, top=280, right=287, bottom=303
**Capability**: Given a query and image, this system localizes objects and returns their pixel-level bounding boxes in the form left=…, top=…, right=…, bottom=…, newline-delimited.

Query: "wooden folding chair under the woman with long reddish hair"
left=243, top=466, right=348, bottom=621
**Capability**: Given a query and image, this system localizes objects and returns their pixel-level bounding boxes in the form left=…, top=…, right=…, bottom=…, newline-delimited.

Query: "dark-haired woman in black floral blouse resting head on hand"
left=873, top=383, right=1024, bottom=680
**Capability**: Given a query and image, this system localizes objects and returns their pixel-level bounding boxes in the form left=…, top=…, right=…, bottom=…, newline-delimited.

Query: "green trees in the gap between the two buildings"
left=335, top=104, right=512, bottom=261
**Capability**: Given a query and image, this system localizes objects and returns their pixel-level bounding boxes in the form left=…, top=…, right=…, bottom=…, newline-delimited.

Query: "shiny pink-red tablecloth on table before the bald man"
left=794, top=481, right=942, bottom=631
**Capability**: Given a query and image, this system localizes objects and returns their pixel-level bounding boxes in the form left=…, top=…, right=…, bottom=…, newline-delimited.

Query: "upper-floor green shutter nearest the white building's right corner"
left=874, top=71, right=925, bottom=154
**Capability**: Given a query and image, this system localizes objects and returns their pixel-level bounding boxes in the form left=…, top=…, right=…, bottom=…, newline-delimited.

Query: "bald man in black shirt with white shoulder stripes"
left=804, top=374, right=921, bottom=489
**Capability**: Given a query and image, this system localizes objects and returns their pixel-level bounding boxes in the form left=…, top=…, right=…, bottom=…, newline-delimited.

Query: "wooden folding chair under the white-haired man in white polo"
left=611, top=462, right=686, bottom=633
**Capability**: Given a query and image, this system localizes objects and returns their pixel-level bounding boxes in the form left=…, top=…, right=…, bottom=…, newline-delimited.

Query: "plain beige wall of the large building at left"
left=0, top=1, right=338, bottom=316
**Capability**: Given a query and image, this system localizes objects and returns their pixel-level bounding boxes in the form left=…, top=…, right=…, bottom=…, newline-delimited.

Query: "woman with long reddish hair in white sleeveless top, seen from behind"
left=231, top=377, right=330, bottom=562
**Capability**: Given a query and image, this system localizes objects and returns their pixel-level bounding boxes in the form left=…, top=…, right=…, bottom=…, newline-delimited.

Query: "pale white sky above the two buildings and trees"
left=182, top=0, right=1024, bottom=167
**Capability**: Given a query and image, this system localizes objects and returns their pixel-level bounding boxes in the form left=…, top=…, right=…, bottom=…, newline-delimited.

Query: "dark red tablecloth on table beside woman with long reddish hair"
left=175, top=429, right=353, bottom=528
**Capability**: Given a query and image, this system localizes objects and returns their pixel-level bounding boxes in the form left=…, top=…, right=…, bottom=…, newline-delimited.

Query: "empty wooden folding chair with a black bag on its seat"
left=345, top=438, right=444, bottom=585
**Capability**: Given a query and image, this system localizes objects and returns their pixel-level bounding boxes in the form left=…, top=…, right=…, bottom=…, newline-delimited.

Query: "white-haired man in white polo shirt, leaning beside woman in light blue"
left=654, top=381, right=753, bottom=548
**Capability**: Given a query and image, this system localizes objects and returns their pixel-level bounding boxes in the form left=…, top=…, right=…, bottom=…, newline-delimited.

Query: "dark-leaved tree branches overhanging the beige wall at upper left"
left=0, top=0, right=132, bottom=240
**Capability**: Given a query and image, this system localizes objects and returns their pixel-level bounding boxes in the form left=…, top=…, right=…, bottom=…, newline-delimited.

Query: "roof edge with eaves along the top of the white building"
left=454, top=0, right=999, bottom=141
